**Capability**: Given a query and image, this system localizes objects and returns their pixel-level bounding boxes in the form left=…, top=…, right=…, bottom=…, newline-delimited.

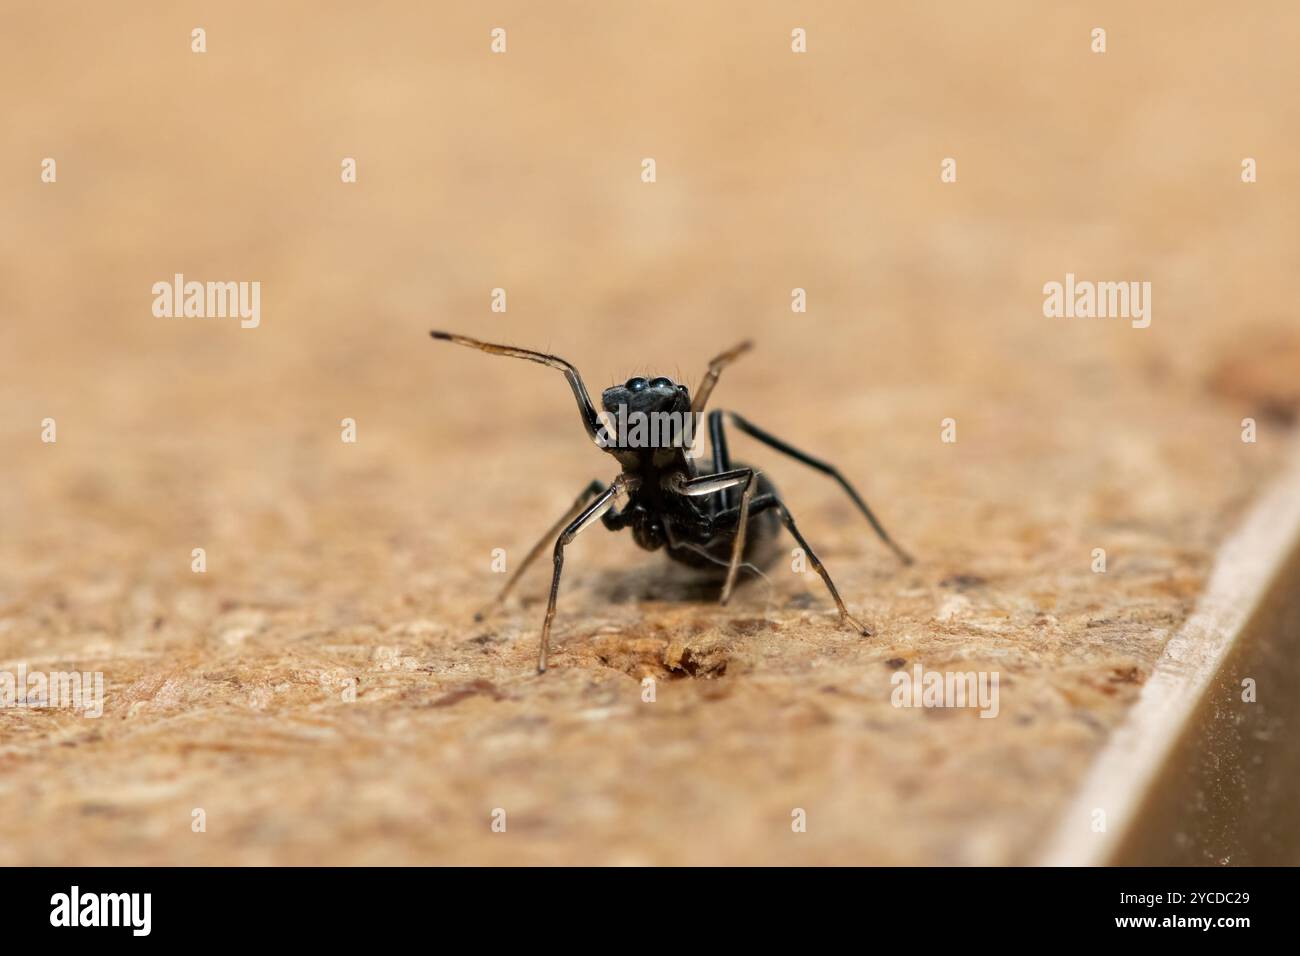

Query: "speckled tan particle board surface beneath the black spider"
left=0, top=3, right=1300, bottom=864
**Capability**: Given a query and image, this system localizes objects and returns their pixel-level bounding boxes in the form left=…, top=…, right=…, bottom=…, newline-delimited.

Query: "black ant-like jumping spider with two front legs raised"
left=429, top=332, right=911, bottom=671
